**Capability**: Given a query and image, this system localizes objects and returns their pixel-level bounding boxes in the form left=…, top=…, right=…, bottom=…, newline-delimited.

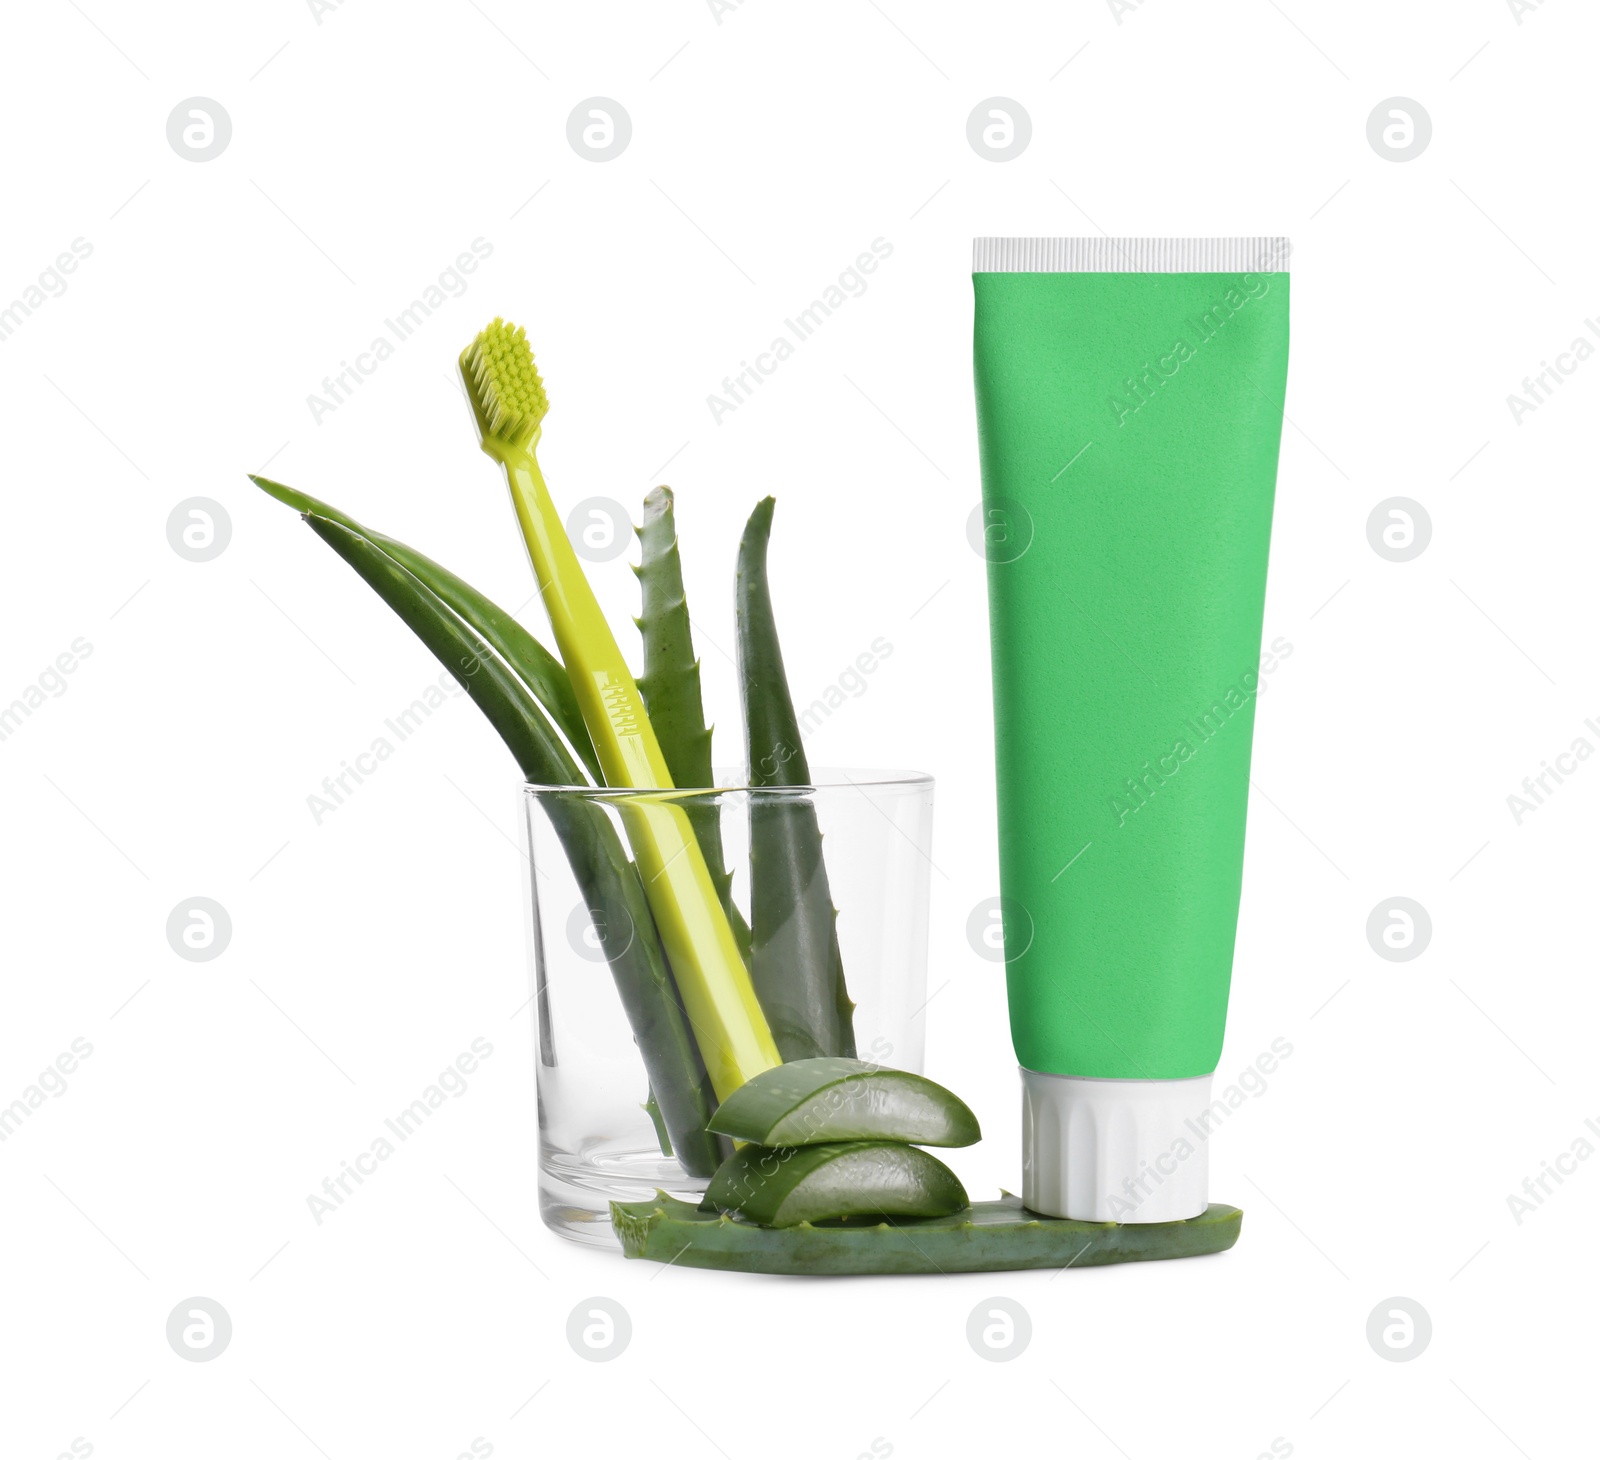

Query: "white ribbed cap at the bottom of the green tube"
left=1022, top=1069, right=1211, bottom=1223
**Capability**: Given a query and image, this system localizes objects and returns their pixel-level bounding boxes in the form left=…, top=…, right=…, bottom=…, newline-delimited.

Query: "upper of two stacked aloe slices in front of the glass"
left=710, top=1057, right=981, bottom=1146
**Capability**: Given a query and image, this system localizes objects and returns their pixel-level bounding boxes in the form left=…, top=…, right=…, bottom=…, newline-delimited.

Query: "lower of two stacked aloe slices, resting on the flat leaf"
left=706, top=1141, right=966, bottom=1226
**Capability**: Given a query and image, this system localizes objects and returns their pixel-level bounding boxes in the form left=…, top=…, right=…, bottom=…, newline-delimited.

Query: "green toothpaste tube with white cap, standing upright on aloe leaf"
left=973, top=239, right=1290, bottom=1221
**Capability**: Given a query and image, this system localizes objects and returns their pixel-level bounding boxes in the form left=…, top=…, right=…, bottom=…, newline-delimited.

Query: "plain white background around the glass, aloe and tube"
left=0, top=0, right=1600, bottom=1460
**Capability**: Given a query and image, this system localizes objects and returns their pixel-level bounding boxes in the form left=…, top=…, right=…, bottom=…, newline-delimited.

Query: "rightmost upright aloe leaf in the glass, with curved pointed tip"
left=734, top=496, right=856, bottom=1061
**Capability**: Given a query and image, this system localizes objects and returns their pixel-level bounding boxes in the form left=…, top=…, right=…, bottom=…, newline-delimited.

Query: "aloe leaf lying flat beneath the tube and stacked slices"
left=611, top=1193, right=1243, bottom=1278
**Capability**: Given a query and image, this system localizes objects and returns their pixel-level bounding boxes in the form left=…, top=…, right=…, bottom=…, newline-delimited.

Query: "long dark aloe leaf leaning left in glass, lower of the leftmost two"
left=306, top=512, right=726, bottom=1175
